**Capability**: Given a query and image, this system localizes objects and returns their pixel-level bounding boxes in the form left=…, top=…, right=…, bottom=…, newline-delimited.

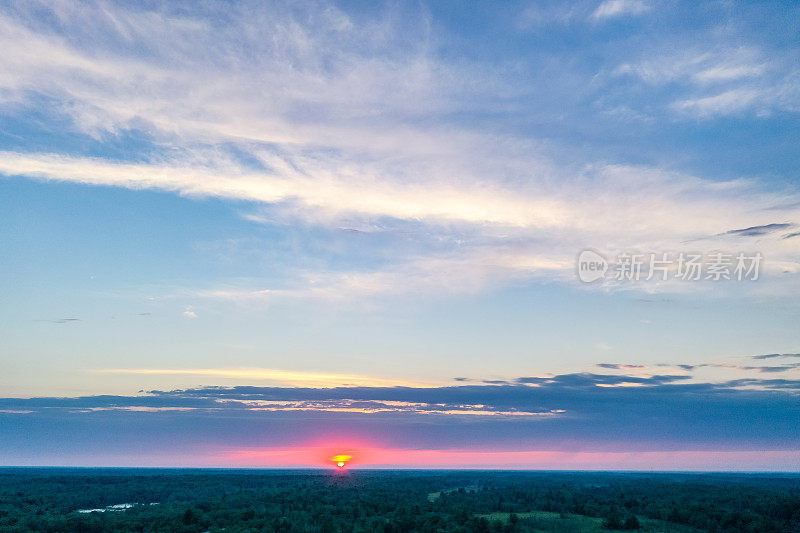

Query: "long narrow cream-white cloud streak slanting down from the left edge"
left=0, top=152, right=565, bottom=227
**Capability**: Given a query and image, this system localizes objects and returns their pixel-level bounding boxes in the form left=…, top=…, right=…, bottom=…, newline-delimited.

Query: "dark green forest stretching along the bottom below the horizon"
left=0, top=468, right=800, bottom=533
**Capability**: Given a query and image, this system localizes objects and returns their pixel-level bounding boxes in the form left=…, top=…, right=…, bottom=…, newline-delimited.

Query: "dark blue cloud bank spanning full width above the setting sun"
left=0, top=373, right=800, bottom=461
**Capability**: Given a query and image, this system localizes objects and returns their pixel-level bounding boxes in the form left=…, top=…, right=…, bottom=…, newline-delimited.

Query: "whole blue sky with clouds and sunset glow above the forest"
left=0, top=0, right=800, bottom=471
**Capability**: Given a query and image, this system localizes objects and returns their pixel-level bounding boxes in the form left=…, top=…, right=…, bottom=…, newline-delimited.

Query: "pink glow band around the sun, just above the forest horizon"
left=214, top=446, right=800, bottom=471
